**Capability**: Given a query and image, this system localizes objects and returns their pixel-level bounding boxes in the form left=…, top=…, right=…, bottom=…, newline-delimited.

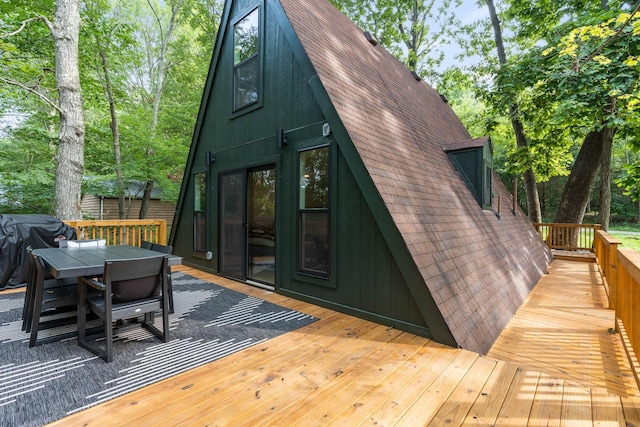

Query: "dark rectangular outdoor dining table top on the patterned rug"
left=33, top=245, right=182, bottom=279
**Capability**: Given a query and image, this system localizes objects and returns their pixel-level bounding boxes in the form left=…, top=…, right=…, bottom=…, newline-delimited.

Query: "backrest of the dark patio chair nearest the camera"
left=103, top=256, right=168, bottom=304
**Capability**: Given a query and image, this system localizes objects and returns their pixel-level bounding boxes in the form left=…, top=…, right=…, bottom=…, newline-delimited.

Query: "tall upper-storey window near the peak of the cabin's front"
left=233, top=8, right=260, bottom=110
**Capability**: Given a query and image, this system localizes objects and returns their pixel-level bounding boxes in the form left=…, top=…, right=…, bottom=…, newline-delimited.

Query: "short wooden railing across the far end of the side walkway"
left=533, top=222, right=602, bottom=252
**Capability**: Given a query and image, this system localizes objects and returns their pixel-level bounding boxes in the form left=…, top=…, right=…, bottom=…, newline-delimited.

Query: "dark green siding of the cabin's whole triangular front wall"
left=171, top=0, right=431, bottom=342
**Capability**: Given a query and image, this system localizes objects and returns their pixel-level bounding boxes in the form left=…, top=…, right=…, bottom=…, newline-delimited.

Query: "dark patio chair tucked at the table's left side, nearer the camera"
left=22, top=253, right=78, bottom=347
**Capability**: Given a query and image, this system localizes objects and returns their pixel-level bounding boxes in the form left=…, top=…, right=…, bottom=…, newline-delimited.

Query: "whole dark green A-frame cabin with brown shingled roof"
left=170, top=0, right=551, bottom=353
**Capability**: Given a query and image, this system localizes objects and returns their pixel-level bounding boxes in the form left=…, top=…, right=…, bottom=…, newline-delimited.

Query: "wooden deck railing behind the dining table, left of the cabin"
left=64, top=219, right=167, bottom=246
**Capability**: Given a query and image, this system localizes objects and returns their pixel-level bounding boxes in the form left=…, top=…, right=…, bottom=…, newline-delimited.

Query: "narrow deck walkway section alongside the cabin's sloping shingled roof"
left=488, top=260, right=640, bottom=397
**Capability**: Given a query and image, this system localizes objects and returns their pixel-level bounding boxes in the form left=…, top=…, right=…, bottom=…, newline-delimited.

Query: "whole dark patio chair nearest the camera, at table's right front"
left=78, top=256, right=169, bottom=362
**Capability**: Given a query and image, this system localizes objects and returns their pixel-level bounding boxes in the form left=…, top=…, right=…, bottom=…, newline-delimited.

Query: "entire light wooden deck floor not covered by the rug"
left=36, top=261, right=640, bottom=427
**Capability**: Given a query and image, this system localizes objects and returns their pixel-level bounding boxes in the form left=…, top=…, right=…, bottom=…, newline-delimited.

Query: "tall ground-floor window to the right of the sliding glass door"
left=298, top=146, right=330, bottom=277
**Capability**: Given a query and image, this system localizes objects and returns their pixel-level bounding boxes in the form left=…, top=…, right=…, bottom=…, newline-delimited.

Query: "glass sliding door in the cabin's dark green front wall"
left=220, top=166, right=276, bottom=286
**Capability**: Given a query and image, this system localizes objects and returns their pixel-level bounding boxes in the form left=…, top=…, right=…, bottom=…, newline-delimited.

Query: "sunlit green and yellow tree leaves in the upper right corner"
left=445, top=0, right=640, bottom=224
